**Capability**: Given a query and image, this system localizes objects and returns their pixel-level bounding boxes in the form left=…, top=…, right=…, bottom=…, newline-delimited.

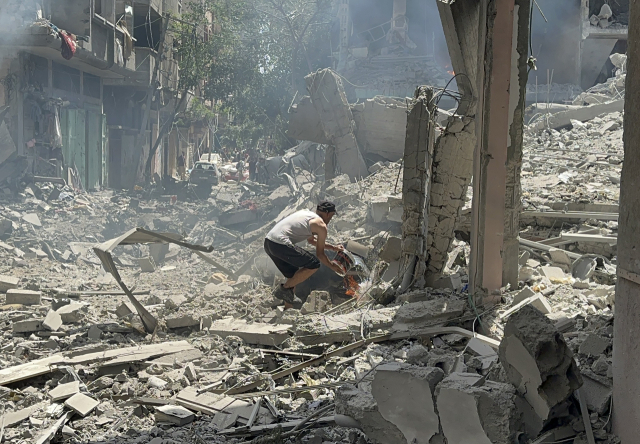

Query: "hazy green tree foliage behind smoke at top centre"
left=173, top=0, right=333, bottom=153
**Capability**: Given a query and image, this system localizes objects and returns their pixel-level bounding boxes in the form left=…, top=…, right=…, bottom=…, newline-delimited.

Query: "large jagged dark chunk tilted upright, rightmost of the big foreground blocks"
left=499, top=305, right=582, bottom=421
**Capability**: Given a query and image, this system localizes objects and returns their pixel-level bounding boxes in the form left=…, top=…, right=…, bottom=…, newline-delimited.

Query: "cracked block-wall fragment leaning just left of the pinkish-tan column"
left=427, top=117, right=476, bottom=283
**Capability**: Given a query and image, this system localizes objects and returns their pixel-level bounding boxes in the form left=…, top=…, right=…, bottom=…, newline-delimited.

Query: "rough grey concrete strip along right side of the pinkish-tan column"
left=502, top=0, right=531, bottom=288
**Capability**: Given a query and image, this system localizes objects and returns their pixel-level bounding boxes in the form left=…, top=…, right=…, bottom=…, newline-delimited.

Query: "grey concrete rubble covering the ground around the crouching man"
left=0, top=59, right=623, bottom=444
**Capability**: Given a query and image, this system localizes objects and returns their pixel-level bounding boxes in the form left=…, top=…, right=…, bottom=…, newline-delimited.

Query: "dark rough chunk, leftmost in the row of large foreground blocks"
left=335, top=385, right=407, bottom=444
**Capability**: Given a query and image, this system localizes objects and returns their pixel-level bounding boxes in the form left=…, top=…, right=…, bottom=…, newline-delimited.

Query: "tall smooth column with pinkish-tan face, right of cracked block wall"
left=470, top=0, right=515, bottom=295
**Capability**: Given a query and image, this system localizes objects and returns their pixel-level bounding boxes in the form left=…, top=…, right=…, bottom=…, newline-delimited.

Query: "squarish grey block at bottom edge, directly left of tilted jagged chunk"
left=436, top=373, right=518, bottom=444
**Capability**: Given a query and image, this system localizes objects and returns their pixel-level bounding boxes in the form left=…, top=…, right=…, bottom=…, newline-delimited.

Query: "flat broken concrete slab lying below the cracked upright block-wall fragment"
left=393, top=298, right=465, bottom=331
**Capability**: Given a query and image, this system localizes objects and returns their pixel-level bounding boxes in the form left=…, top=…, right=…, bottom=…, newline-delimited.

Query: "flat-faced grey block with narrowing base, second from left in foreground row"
left=371, top=362, right=444, bottom=444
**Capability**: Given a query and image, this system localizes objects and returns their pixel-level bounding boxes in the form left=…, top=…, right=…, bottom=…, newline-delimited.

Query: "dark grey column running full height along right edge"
left=613, top=0, right=640, bottom=438
